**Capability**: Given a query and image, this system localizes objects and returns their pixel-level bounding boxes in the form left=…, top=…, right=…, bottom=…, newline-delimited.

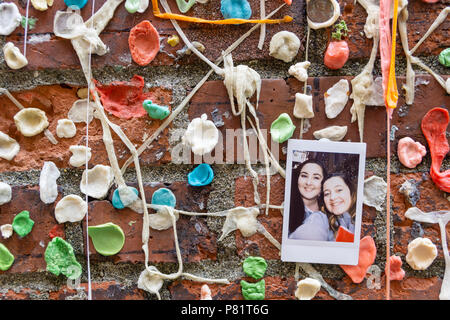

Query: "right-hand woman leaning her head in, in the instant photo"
left=323, top=173, right=356, bottom=241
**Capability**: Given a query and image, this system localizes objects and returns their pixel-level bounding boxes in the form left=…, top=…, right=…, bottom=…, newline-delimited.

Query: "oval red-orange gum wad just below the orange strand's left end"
left=128, top=20, right=159, bottom=66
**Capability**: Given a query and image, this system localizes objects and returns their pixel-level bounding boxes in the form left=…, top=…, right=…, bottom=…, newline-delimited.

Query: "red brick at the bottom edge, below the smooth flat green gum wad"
left=49, top=281, right=146, bottom=300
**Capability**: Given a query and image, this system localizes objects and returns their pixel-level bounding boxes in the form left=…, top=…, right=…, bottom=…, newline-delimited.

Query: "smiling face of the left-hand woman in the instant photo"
left=298, top=163, right=323, bottom=200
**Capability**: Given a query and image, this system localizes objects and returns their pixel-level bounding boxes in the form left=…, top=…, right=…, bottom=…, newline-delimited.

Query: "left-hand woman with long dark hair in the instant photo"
left=288, top=159, right=329, bottom=241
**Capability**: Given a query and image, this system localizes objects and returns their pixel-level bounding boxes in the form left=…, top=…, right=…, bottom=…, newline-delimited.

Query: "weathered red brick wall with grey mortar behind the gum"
left=0, top=0, right=450, bottom=300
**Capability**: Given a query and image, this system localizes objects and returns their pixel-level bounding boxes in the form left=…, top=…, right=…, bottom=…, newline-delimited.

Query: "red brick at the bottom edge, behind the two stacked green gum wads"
left=169, top=276, right=297, bottom=300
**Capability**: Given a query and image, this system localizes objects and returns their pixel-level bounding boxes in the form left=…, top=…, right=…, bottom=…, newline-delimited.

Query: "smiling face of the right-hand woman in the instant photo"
left=323, top=177, right=352, bottom=215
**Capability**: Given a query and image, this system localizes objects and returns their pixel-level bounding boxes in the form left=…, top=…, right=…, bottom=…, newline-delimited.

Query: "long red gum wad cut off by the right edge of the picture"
left=421, top=108, right=450, bottom=192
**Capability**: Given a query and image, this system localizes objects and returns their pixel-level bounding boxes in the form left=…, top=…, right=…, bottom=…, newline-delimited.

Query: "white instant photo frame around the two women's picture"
left=281, top=139, right=366, bottom=265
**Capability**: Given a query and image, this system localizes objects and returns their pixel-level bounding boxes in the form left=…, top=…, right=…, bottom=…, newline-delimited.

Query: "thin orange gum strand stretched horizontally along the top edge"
left=152, top=0, right=292, bottom=24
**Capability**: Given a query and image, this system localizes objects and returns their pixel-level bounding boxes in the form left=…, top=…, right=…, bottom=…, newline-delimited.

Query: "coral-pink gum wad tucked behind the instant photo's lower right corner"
left=340, top=236, right=377, bottom=283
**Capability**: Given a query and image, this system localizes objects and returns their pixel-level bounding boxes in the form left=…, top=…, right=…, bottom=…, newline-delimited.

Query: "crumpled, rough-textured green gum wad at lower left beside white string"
left=44, top=237, right=82, bottom=280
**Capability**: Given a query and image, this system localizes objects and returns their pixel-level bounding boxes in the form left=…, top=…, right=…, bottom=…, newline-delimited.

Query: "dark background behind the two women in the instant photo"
left=288, top=150, right=360, bottom=234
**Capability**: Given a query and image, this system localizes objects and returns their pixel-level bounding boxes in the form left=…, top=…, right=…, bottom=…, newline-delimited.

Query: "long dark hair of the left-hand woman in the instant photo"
left=288, top=159, right=327, bottom=234
